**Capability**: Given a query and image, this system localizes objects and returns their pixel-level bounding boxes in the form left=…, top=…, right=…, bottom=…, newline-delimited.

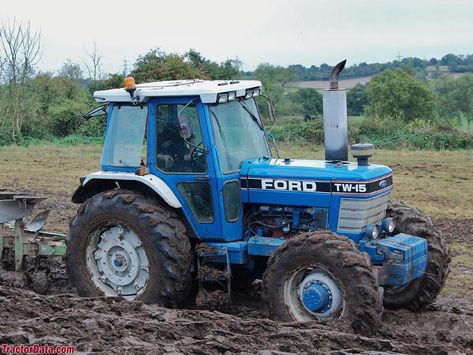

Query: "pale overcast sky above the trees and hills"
left=0, top=0, right=473, bottom=72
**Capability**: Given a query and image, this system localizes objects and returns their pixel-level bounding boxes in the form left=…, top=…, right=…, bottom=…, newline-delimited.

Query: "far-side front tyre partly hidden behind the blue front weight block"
left=384, top=203, right=450, bottom=311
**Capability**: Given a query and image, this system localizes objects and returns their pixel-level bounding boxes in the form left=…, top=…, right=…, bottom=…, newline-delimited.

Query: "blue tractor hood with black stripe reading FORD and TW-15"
left=240, top=158, right=392, bottom=204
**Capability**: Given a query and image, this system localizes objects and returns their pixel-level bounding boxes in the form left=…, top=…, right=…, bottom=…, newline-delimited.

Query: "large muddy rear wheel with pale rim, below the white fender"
left=65, top=190, right=193, bottom=307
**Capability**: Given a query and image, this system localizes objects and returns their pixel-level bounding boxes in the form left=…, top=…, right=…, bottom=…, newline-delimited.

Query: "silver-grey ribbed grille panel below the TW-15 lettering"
left=338, top=193, right=389, bottom=233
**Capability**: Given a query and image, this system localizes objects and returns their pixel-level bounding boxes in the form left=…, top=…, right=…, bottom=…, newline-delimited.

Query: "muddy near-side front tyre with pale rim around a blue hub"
left=263, top=231, right=383, bottom=335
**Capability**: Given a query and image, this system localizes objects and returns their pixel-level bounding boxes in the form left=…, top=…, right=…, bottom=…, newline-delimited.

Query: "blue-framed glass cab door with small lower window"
left=147, top=97, right=222, bottom=240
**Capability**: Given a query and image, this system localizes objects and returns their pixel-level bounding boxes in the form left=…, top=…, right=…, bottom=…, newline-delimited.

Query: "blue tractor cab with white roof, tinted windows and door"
left=84, top=80, right=271, bottom=241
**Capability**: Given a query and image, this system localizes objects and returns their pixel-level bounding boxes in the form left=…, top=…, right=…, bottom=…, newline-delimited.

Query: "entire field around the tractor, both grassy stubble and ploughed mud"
left=0, top=147, right=473, bottom=354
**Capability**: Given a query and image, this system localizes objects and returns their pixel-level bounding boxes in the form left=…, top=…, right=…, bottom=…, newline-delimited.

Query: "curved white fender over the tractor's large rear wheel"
left=72, top=171, right=182, bottom=208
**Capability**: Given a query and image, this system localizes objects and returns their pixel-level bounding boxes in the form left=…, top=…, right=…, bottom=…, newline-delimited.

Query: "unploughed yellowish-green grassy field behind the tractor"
left=0, top=144, right=473, bottom=300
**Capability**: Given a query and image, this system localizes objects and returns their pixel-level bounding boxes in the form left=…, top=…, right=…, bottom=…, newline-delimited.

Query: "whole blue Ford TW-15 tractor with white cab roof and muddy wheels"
left=66, top=62, right=449, bottom=334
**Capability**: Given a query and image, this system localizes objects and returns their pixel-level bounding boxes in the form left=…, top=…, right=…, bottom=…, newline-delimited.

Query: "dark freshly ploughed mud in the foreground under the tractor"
left=0, top=196, right=473, bottom=354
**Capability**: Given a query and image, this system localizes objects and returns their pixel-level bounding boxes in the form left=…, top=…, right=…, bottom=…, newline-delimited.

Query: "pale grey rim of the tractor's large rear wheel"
left=86, top=225, right=149, bottom=299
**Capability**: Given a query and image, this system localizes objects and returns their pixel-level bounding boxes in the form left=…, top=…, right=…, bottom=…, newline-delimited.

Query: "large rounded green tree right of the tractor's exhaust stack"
left=365, top=69, right=435, bottom=123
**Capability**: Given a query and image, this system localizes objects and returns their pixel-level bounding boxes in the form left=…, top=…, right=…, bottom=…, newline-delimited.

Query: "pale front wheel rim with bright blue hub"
left=284, top=267, right=344, bottom=321
